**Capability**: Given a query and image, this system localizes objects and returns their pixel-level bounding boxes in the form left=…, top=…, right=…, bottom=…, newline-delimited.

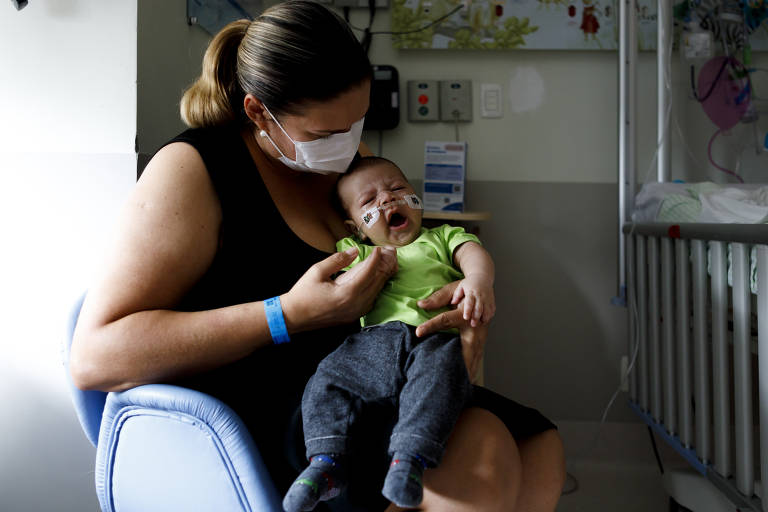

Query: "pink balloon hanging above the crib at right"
left=697, top=57, right=750, bottom=130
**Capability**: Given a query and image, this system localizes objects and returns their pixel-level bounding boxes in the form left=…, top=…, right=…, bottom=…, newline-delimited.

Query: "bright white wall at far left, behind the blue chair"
left=0, top=0, right=136, bottom=512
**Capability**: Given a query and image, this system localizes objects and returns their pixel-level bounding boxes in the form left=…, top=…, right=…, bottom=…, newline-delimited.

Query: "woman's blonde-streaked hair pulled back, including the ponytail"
left=181, top=0, right=371, bottom=128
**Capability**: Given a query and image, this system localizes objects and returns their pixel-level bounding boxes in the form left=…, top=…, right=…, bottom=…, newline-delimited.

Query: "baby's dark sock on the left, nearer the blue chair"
left=283, top=454, right=347, bottom=512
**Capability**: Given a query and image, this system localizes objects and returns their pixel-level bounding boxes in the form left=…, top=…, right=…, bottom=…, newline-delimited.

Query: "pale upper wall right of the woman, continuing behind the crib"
left=352, top=9, right=768, bottom=183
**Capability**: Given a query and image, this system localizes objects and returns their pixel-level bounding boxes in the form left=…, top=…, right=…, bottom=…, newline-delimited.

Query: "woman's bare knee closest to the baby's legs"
left=423, top=409, right=521, bottom=512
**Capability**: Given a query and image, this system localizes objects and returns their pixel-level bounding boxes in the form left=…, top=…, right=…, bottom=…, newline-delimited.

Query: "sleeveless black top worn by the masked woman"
left=163, top=127, right=359, bottom=465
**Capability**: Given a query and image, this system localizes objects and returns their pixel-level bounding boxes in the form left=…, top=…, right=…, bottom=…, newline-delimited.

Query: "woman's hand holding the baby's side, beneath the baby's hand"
left=416, top=281, right=488, bottom=382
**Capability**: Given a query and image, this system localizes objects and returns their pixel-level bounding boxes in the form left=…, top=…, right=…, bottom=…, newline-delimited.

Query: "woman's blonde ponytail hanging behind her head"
left=181, top=20, right=251, bottom=128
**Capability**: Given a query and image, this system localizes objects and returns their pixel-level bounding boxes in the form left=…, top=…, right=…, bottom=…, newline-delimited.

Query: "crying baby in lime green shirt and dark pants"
left=283, top=157, right=495, bottom=512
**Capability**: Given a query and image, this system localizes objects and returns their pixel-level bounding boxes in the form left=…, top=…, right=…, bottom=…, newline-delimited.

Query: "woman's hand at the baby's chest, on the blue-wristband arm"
left=280, top=247, right=397, bottom=333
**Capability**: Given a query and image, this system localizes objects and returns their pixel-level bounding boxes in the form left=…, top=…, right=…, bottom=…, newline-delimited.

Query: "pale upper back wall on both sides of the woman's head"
left=138, top=0, right=768, bottom=183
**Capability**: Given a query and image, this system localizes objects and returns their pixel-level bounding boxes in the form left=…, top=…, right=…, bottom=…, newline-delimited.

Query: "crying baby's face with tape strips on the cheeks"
left=339, top=162, right=422, bottom=247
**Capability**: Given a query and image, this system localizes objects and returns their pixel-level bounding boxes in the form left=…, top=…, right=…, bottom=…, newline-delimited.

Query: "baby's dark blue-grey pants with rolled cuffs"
left=301, top=322, right=472, bottom=466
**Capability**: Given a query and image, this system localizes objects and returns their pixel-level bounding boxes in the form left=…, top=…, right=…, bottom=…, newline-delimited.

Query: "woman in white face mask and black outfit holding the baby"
left=70, top=0, right=564, bottom=512
